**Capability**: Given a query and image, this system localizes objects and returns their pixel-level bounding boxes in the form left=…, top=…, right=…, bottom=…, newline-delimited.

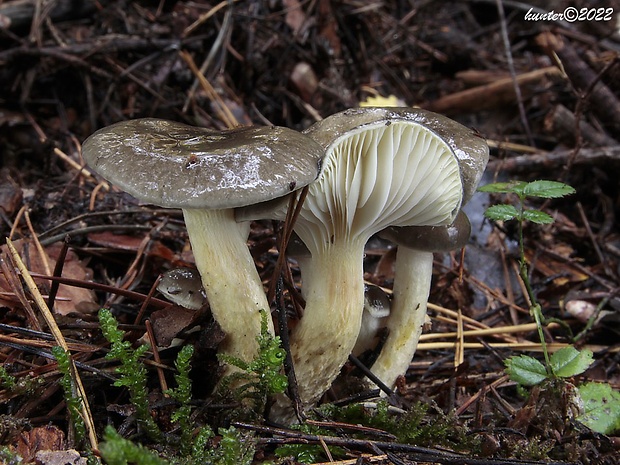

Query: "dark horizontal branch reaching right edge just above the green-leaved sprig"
left=488, top=145, right=620, bottom=173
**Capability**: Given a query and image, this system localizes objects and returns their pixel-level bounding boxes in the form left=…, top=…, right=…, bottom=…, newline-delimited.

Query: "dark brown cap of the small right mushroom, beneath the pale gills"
left=379, top=211, right=471, bottom=252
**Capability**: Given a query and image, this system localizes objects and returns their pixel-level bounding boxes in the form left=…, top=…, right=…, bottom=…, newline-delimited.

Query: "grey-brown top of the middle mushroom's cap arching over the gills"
left=304, top=107, right=489, bottom=204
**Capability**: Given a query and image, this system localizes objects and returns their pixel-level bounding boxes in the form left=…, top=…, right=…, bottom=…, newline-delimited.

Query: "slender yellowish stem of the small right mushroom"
left=371, top=247, right=433, bottom=387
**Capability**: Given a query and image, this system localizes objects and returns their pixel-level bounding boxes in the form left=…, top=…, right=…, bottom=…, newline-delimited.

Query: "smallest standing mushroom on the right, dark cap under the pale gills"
left=371, top=211, right=471, bottom=387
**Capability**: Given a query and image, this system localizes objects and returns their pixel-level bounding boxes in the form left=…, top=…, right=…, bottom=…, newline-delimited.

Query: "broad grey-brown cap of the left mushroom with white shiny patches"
left=82, top=118, right=324, bottom=209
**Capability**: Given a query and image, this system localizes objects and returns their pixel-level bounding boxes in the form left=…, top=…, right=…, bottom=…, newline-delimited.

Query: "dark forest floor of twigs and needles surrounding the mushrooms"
left=0, top=0, right=620, bottom=465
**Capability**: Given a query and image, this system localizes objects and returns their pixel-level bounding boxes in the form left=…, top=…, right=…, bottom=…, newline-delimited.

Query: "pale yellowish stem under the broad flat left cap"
left=183, top=208, right=273, bottom=362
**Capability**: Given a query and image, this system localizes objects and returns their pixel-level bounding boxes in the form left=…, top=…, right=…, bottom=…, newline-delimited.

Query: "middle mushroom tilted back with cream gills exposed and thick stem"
left=272, top=108, right=463, bottom=419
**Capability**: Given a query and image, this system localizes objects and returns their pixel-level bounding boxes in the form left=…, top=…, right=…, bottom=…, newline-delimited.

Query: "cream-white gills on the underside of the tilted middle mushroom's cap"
left=295, top=117, right=463, bottom=250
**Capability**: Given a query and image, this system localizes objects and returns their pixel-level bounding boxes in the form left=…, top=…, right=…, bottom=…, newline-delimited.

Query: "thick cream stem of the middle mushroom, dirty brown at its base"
left=274, top=238, right=364, bottom=418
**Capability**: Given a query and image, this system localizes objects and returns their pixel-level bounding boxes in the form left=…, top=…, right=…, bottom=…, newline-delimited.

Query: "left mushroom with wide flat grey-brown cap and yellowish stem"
left=82, top=118, right=323, bottom=362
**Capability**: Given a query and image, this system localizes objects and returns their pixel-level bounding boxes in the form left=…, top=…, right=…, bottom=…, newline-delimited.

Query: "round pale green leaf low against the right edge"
left=577, top=383, right=620, bottom=434
